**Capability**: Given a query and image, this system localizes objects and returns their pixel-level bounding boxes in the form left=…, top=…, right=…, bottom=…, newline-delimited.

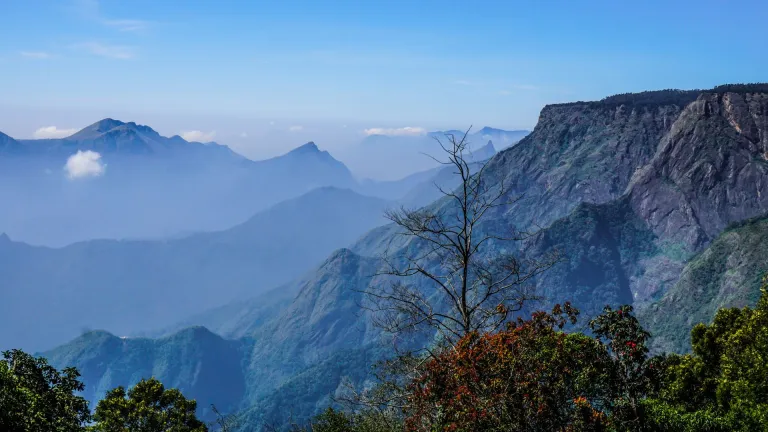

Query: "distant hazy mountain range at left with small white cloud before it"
left=0, top=119, right=356, bottom=247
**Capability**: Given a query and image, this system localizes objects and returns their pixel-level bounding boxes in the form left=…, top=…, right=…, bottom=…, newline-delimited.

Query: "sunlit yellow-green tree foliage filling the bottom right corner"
left=645, top=284, right=768, bottom=431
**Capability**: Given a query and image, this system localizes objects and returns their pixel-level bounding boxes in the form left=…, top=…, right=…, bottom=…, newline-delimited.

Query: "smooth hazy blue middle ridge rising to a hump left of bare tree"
left=0, top=188, right=388, bottom=350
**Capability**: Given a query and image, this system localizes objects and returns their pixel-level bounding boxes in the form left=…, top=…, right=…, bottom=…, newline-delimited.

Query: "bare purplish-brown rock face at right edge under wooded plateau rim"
left=629, top=92, right=768, bottom=251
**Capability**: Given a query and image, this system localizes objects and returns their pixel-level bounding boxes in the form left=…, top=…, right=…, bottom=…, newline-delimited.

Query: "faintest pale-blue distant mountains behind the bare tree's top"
left=339, top=127, right=528, bottom=181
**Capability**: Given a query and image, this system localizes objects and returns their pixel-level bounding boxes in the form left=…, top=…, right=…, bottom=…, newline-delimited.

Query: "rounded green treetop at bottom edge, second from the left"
left=93, top=379, right=208, bottom=432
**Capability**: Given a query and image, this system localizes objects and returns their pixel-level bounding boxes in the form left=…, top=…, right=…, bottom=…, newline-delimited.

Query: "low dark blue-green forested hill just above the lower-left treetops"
left=44, top=327, right=245, bottom=419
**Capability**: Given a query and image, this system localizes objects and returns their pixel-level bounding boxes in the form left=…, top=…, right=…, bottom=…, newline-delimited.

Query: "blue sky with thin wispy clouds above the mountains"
left=0, top=0, right=768, bottom=155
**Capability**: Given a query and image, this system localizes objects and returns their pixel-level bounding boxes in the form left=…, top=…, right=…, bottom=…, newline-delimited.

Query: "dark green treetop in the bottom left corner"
left=0, top=350, right=90, bottom=432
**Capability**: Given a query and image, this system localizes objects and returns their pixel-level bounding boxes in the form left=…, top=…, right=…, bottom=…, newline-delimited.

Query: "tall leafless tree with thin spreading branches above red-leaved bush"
left=363, top=128, right=558, bottom=345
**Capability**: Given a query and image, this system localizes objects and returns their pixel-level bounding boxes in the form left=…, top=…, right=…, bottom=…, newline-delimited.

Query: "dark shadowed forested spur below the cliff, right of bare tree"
left=525, top=199, right=662, bottom=317
